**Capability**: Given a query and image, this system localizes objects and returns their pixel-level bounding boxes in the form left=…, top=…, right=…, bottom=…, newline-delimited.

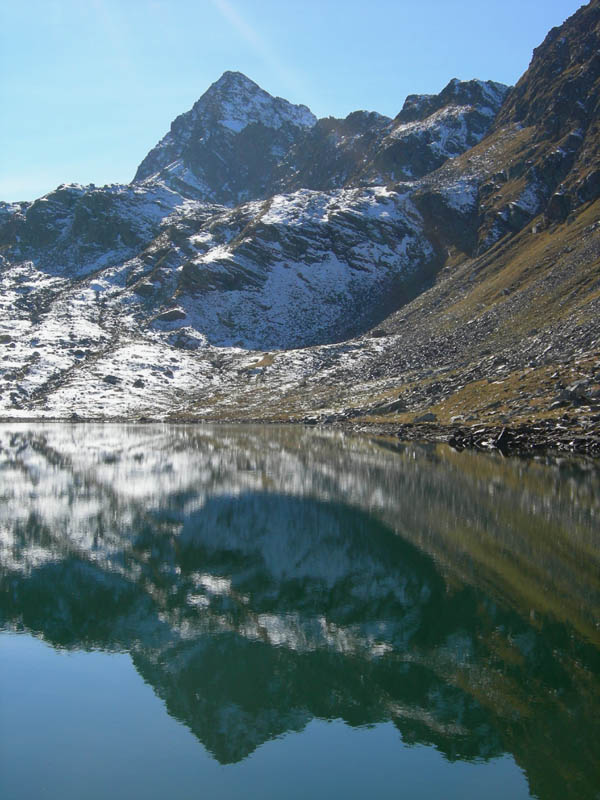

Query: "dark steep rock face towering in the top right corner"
left=486, top=0, right=600, bottom=223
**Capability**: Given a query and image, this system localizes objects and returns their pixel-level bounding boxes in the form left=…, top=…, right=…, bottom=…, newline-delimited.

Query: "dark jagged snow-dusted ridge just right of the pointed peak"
left=274, top=80, right=508, bottom=191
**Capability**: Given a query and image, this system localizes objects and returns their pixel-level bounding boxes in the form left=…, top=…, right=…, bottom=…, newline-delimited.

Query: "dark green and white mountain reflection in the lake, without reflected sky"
left=0, top=424, right=600, bottom=798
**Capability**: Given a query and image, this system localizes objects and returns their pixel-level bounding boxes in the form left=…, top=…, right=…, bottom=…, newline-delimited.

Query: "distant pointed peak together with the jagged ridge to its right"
left=134, top=72, right=507, bottom=204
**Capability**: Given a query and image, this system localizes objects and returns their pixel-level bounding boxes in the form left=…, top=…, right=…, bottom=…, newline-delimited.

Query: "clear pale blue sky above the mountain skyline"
left=0, top=0, right=582, bottom=201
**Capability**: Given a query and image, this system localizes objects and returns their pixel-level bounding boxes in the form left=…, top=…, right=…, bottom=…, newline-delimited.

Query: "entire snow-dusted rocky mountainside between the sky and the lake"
left=0, top=0, right=600, bottom=438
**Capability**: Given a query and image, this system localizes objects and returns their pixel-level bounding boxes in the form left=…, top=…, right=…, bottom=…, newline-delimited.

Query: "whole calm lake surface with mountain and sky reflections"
left=0, top=424, right=600, bottom=800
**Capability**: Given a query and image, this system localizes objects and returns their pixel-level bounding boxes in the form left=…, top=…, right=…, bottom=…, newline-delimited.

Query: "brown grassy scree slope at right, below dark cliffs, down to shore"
left=180, top=195, right=600, bottom=424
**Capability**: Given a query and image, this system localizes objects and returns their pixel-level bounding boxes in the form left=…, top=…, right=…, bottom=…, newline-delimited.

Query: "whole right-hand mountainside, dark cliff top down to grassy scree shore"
left=165, top=0, right=600, bottom=435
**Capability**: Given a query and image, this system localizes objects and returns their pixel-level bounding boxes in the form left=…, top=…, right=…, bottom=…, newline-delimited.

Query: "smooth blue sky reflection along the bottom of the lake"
left=0, top=635, right=530, bottom=800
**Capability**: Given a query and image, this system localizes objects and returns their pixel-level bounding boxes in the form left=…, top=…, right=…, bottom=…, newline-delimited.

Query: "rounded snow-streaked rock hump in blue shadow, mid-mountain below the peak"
left=126, top=187, right=433, bottom=349
